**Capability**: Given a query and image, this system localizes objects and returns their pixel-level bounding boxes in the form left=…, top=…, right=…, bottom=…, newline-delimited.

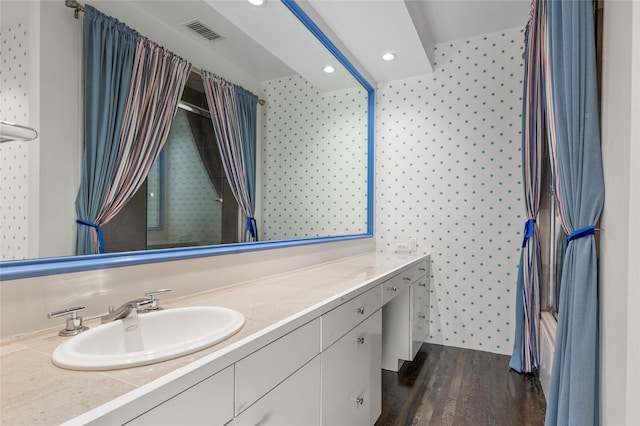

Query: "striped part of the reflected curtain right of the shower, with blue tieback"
left=202, top=71, right=258, bottom=241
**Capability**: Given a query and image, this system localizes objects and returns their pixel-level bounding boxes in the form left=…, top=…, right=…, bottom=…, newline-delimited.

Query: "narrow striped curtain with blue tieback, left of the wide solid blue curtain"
left=509, top=0, right=545, bottom=373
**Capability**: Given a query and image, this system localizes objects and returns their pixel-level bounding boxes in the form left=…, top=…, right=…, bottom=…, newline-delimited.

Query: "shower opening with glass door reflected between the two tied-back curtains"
left=103, top=72, right=240, bottom=253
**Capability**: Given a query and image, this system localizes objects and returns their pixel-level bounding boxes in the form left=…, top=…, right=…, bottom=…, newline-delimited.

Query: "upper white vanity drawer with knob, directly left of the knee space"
left=322, top=286, right=382, bottom=351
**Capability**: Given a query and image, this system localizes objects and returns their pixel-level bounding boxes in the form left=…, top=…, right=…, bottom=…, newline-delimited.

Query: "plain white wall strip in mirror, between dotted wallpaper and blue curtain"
left=37, top=1, right=82, bottom=257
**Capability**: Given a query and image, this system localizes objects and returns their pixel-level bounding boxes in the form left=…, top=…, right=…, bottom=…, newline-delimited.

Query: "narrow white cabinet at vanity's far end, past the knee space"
left=382, top=259, right=429, bottom=371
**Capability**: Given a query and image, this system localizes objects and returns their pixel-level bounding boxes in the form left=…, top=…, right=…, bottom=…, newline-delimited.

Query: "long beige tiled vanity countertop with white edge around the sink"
left=0, top=253, right=424, bottom=425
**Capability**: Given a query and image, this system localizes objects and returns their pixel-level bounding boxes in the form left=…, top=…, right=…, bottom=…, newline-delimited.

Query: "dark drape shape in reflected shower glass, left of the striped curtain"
left=185, top=112, right=224, bottom=197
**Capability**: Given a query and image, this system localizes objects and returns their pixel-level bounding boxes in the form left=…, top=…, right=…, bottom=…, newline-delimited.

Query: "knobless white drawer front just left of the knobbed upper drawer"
left=235, top=318, right=320, bottom=415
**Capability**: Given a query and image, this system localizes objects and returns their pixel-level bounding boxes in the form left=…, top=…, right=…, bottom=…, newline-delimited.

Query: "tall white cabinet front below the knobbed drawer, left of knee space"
left=321, top=310, right=382, bottom=426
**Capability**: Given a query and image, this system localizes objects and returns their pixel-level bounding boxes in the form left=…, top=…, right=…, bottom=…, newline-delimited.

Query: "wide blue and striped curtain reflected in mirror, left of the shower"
left=76, top=6, right=191, bottom=254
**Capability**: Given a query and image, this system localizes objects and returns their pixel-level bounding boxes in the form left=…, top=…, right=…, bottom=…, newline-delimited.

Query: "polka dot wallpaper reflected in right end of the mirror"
left=258, top=76, right=367, bottom=240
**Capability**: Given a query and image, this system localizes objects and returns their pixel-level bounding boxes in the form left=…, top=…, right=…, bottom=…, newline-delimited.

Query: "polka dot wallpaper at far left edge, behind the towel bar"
left=0, top=19, right=33, bottom=260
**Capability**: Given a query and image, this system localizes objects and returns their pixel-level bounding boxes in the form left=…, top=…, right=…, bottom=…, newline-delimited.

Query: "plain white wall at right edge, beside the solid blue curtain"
left=600, top=1, right=640, bottom=425
